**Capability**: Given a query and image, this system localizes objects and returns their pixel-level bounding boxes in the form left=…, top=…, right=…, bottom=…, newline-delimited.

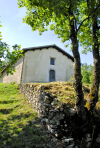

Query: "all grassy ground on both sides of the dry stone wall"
left=0, top=82, right=100, bottom=148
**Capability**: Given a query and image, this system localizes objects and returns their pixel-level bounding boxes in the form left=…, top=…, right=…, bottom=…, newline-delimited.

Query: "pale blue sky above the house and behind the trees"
left=0, top=0, right=93, bottom=65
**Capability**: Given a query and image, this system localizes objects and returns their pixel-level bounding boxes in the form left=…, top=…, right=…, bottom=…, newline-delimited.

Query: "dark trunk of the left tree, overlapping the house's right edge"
left=70, top=22, right=86, bottom=119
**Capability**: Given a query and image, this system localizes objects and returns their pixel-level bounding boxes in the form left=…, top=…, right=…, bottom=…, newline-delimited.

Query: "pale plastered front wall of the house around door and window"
left=22, top=48, right=74, bottom=83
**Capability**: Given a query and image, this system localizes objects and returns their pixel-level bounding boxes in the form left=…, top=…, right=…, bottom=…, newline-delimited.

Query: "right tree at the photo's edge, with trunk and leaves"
left=80, top=0, right=100, bottom=113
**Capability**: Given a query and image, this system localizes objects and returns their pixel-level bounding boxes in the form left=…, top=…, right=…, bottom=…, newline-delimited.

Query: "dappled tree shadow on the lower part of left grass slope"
left=0, top=114, right=44, bottom=148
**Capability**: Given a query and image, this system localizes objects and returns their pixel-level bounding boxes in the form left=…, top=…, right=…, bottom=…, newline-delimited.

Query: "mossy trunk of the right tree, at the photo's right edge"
left=86, top=17, right=99, bottom=113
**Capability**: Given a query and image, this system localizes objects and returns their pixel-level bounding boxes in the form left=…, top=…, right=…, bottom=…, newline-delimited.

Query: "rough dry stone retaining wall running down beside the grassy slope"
left=19, top=84, right=75, bottom=148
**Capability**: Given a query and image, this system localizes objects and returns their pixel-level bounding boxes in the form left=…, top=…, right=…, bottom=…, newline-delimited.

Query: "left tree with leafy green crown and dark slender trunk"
left=18, top=0, right=99, bottom=118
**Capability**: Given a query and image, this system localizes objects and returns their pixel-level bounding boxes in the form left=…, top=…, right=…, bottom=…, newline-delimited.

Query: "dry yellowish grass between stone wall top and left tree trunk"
left=35, top=82, right=76, bottom=107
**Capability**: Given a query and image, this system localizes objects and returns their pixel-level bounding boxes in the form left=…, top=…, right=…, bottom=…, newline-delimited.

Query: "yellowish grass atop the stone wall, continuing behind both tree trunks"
left=28, top=82, right=100, bottom=112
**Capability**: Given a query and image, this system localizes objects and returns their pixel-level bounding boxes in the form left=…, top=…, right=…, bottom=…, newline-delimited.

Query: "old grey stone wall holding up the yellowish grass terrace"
left=19, top=84, right=99, bottom=148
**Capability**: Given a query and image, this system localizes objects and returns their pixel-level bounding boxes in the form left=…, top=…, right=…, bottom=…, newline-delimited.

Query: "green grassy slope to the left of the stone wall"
left=0, top=83, right=44, bottom=148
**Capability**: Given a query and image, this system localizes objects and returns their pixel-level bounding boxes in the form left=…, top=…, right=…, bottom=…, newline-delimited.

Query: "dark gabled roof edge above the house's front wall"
left=23, top=44, right=74, bottom=62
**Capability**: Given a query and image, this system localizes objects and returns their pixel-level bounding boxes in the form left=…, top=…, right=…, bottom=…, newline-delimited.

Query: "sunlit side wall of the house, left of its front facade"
left=2, top=58, right=23, bottom=84
